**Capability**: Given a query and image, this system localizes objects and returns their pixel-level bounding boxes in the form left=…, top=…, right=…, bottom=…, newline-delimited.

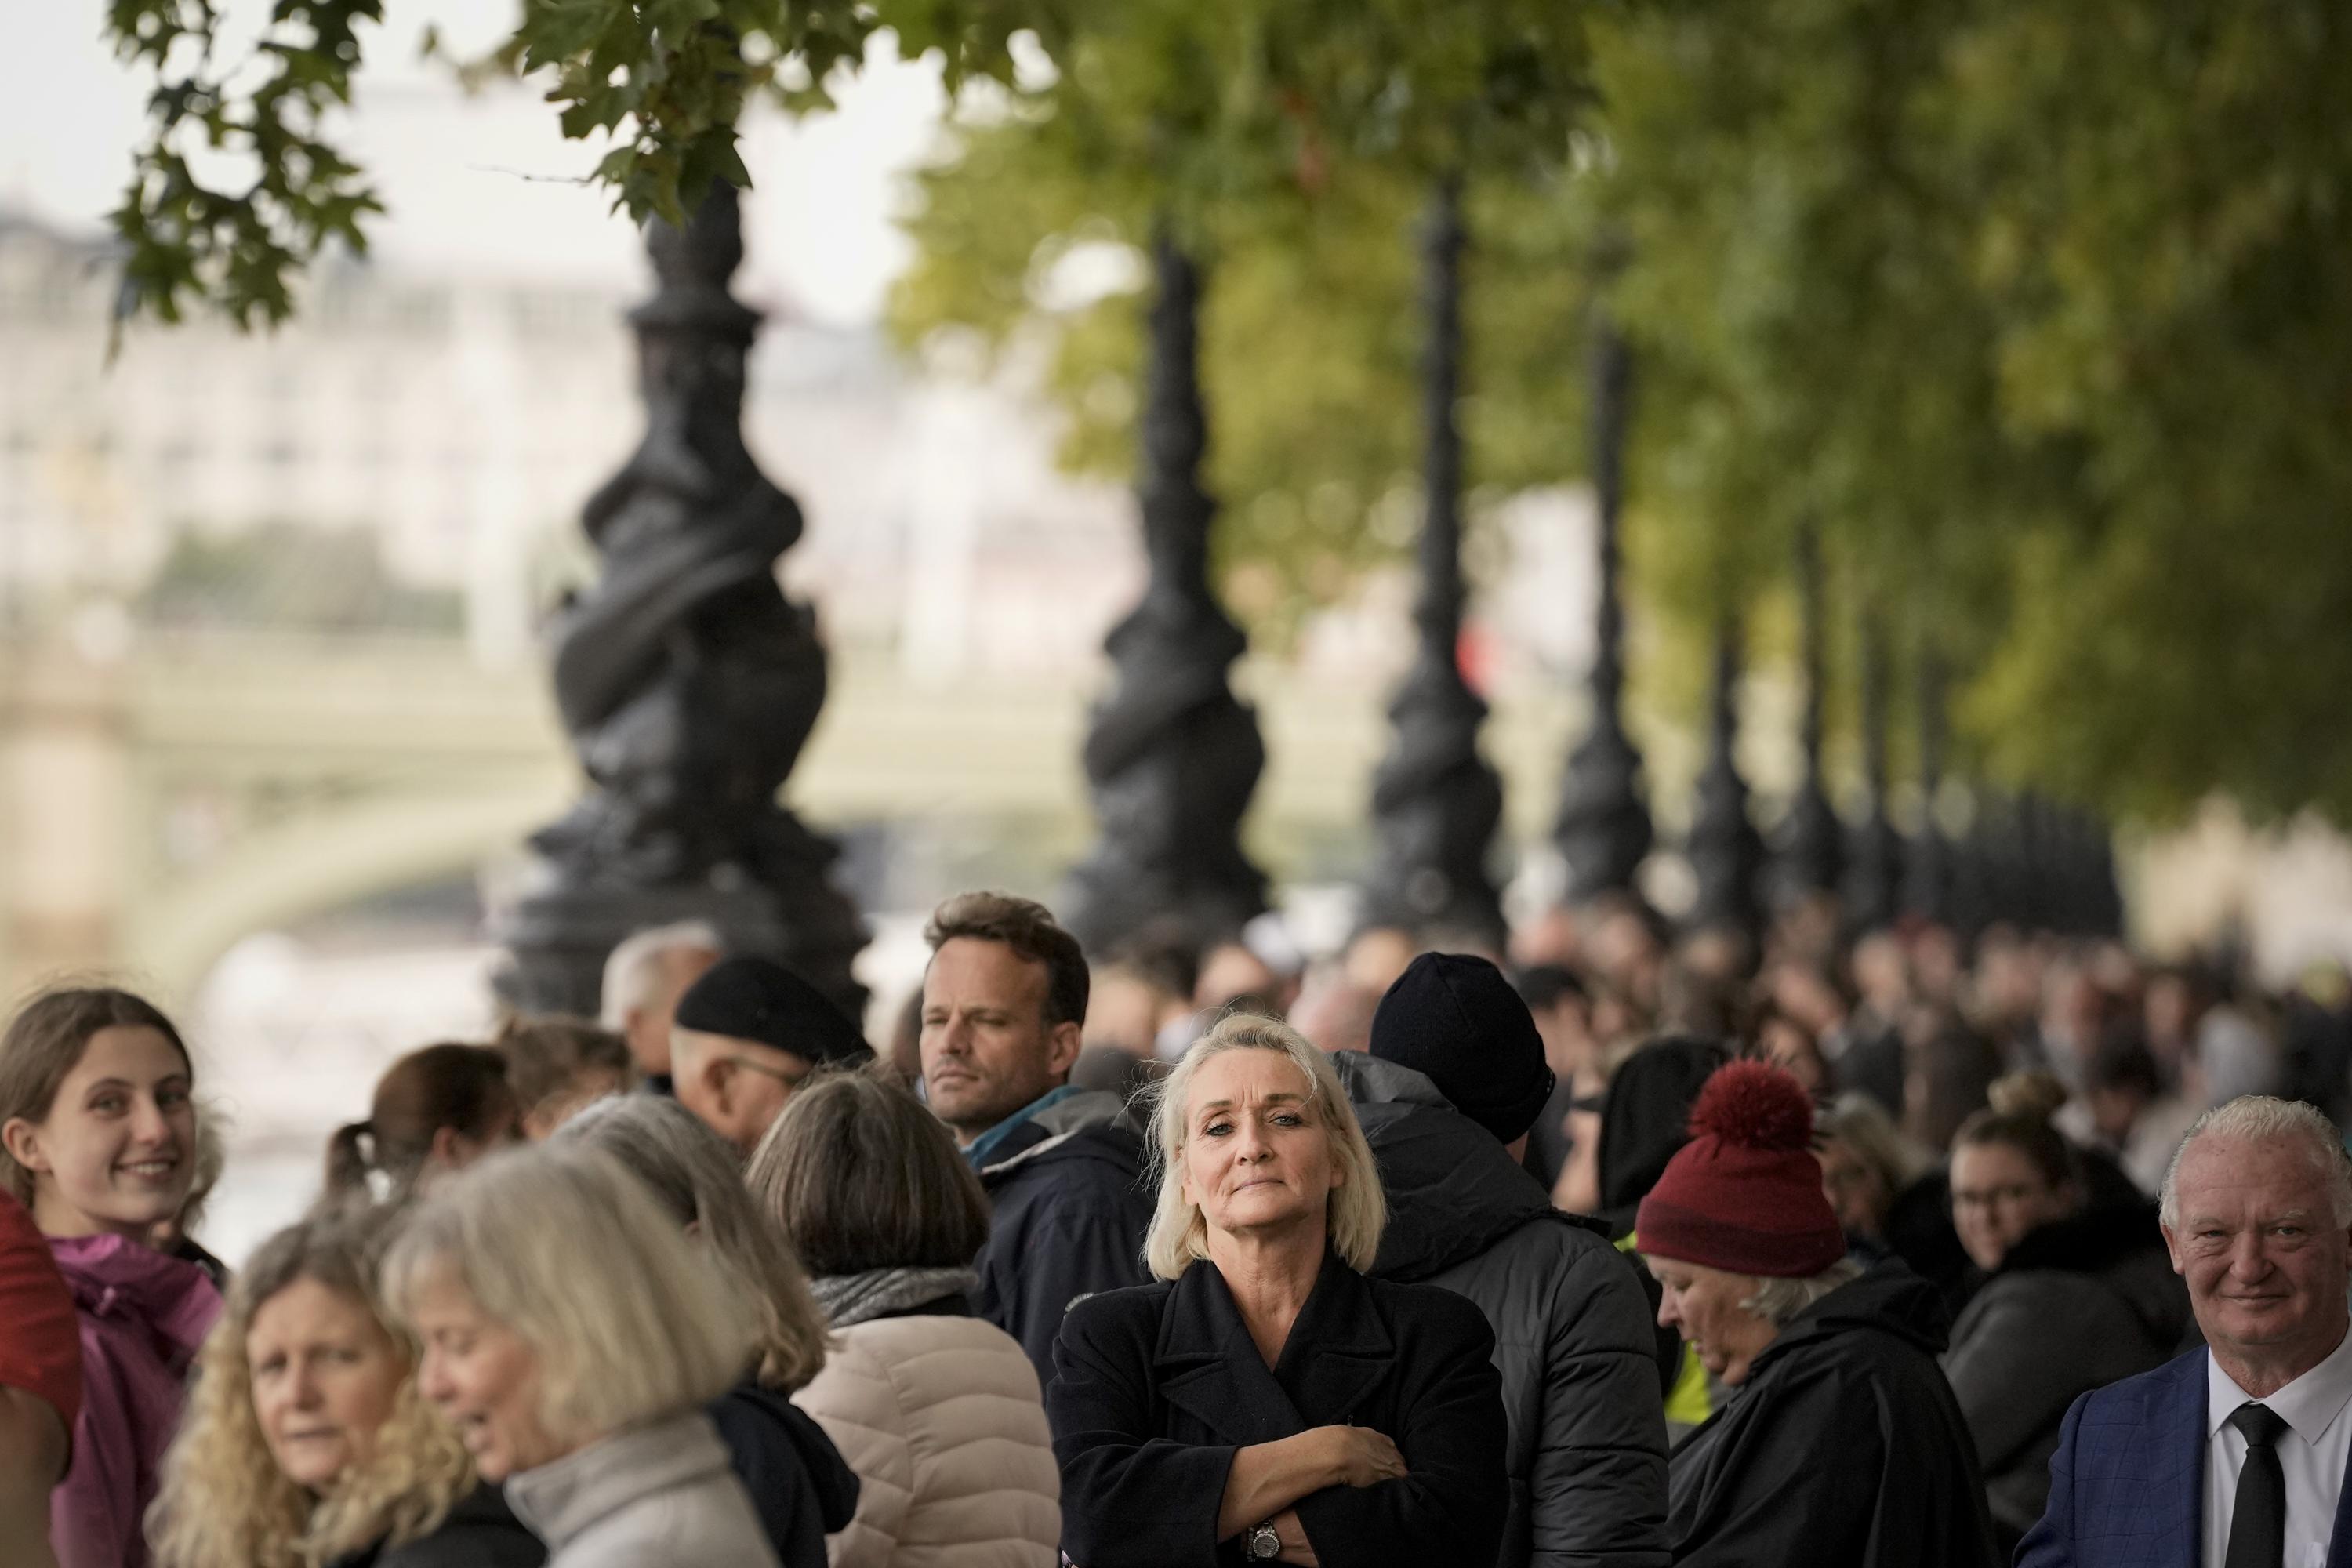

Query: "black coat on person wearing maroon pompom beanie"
left=1668, top=1262, right=1994, bottom=1568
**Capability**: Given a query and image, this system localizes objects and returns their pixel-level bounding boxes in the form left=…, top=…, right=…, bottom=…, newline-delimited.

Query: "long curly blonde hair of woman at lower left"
left=148, top=1208, right=475, bottom=1568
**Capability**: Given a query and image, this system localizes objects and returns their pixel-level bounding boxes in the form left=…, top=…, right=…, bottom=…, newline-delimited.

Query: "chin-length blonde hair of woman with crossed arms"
left=1143, top=1013, right=1388, bottom=1279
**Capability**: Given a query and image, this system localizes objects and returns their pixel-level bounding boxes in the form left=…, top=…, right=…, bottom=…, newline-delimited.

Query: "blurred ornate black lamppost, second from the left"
left=1063, top=228, right=1265, bottom=952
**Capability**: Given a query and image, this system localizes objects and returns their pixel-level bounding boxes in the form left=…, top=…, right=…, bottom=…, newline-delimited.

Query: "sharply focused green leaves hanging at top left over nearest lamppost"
left=106, top=0, right=1030, bottom=327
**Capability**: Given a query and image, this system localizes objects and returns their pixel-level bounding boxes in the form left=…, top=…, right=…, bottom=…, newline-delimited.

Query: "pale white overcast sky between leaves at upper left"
left=0, top=0, right=943, bottom=322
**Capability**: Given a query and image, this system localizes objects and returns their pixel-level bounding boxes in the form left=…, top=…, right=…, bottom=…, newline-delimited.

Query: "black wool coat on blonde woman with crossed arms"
left=1044, top=1253, right=1510, bottom=1568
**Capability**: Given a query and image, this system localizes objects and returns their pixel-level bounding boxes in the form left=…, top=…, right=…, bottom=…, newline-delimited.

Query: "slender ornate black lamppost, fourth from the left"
left=1552, top=315, right=1653, bottom=902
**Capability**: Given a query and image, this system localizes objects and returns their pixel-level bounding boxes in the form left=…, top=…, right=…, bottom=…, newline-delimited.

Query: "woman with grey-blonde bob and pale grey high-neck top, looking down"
left=383, top=1147, right=786, bottom=1568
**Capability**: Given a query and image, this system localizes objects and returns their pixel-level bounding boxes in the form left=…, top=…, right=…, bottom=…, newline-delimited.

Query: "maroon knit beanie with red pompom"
left=1635, top=1060, right=1846, bottom=1279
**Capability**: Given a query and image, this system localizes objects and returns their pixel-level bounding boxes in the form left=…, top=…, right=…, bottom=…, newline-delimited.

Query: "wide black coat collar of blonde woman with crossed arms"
left=1152, top=1250, right=1397, bottom=1446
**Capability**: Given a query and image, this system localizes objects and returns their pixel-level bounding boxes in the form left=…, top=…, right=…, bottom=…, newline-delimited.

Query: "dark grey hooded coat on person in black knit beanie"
left=1331, top=1051, right=1668, bottom=1568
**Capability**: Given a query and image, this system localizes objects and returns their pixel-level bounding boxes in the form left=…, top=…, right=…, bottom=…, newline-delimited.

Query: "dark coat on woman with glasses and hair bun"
left=1943, top=1203, right=2197, bottom=1544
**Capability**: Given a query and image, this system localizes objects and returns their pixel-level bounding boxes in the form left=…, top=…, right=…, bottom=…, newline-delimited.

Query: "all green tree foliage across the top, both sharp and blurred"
left=108, top=0, right=2352, bottom=820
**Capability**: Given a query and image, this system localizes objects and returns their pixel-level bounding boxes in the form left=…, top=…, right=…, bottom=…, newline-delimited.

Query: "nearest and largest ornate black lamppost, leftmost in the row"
left=499, top=183, right=866, bottom=1018
